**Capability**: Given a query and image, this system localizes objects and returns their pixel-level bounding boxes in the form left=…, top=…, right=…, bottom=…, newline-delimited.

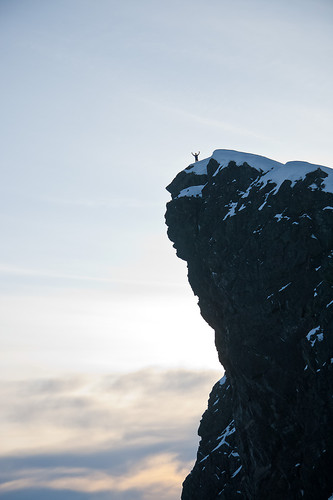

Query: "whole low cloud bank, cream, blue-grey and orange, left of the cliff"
left=0, top=368, right=221, bottom=500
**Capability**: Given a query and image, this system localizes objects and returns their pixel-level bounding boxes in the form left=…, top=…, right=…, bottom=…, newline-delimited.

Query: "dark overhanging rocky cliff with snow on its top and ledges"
left=166, top=150, right=333, bottom=500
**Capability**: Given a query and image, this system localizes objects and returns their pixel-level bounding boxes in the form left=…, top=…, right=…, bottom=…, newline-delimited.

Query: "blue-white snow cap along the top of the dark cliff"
left=178, top=149, right=333, bottom=197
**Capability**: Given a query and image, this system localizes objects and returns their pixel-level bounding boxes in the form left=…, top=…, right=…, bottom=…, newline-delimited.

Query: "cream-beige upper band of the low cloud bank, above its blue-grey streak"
left=0, top=368, right=219, bottom=448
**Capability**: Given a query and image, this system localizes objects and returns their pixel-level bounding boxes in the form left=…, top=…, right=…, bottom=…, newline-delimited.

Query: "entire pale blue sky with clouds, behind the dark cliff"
left=0, top=0, right=333, bottom=500
